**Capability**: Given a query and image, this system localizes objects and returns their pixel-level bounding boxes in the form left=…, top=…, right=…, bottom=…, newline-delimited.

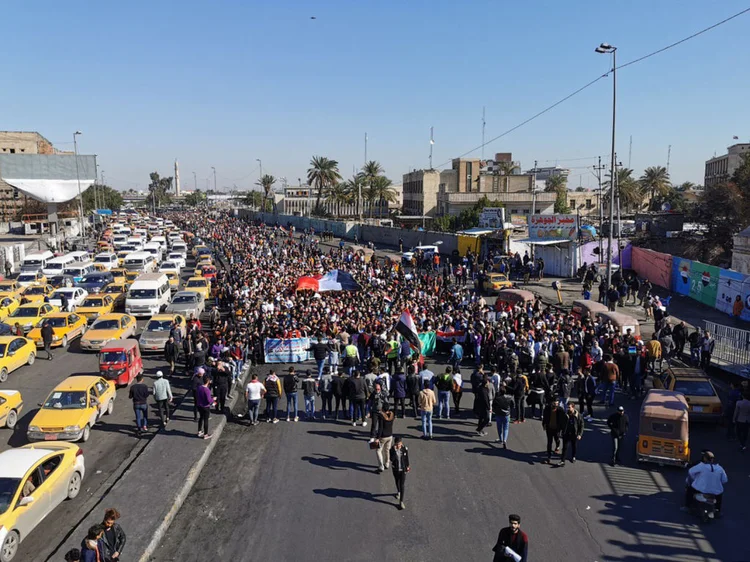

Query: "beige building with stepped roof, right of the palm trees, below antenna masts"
left=437, top=159, right=556, bottom=216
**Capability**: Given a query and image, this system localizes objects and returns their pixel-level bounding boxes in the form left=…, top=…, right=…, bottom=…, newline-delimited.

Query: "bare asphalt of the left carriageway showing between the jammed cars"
left=0, top=262, right=200, bottom=560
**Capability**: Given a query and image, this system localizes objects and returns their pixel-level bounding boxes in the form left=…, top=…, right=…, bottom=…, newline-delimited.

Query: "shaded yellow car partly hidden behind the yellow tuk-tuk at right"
left=654, top=366, right=723, bottom=421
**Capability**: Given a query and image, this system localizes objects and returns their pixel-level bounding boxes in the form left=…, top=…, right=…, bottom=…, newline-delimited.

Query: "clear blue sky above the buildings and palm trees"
left=0, top=0, right=750, bottom=190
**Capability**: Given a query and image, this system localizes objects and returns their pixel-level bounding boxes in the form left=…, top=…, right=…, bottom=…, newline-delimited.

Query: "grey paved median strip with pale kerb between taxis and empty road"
left=39, top=368, right=251, bottom=562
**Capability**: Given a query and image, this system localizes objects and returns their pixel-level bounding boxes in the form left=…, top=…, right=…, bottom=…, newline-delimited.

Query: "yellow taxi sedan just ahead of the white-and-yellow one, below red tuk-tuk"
left=26, top=375, right=117, bottom=443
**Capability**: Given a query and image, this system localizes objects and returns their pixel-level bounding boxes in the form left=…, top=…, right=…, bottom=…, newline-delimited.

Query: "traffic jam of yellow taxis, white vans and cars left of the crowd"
left=0, top=212, right=217, bottom=562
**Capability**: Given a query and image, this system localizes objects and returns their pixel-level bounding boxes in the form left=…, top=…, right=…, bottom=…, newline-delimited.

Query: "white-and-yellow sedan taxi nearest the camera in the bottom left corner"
left=0, top=443, right=86, bottom=562
